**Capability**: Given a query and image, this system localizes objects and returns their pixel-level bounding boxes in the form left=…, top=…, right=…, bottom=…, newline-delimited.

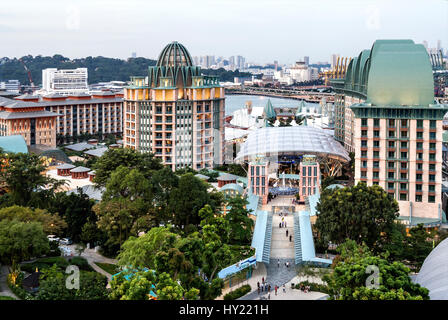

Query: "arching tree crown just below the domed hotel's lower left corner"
left=93, top=148, right=163, bottom=186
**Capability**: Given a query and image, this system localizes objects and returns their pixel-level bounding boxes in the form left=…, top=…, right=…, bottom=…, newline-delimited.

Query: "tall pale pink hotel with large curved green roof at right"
left=332, top=40, right=448, bottom=226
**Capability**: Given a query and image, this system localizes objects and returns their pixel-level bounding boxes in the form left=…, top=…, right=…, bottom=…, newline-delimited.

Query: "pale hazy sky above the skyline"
left=0, top=0, right=448, bottom=63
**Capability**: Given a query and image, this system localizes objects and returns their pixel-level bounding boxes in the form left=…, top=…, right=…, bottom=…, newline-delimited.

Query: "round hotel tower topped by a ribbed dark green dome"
left=123, top=42, right=225, bottom=170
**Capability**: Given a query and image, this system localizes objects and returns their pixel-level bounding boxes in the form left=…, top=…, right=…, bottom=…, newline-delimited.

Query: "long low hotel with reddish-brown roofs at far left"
left=0, top=92, right=123, bottom=147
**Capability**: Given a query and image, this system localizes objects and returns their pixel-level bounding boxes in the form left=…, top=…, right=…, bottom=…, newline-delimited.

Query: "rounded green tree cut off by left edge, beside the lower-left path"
left=0, top=219, right=50, bottom=265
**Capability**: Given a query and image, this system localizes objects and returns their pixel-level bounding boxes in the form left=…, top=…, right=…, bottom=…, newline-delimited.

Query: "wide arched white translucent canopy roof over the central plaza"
left=235, top=126, right=350, bottom=162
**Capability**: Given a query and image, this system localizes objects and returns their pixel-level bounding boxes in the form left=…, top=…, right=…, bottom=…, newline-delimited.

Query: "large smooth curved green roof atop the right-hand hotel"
left=332, top=40, right=434, bottom=106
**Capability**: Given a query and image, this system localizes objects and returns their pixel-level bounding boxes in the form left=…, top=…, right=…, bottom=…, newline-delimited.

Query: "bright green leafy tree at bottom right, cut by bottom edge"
left=324, top=241, right=429, bottom=300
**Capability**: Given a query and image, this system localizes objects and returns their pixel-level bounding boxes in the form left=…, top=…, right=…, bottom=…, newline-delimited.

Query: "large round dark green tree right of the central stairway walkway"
left=315, top=183, right=399, bottom=247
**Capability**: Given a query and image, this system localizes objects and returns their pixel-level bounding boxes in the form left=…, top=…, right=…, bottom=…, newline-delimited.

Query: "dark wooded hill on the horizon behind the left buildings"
left=0, top=54, right=251, bottom=85
